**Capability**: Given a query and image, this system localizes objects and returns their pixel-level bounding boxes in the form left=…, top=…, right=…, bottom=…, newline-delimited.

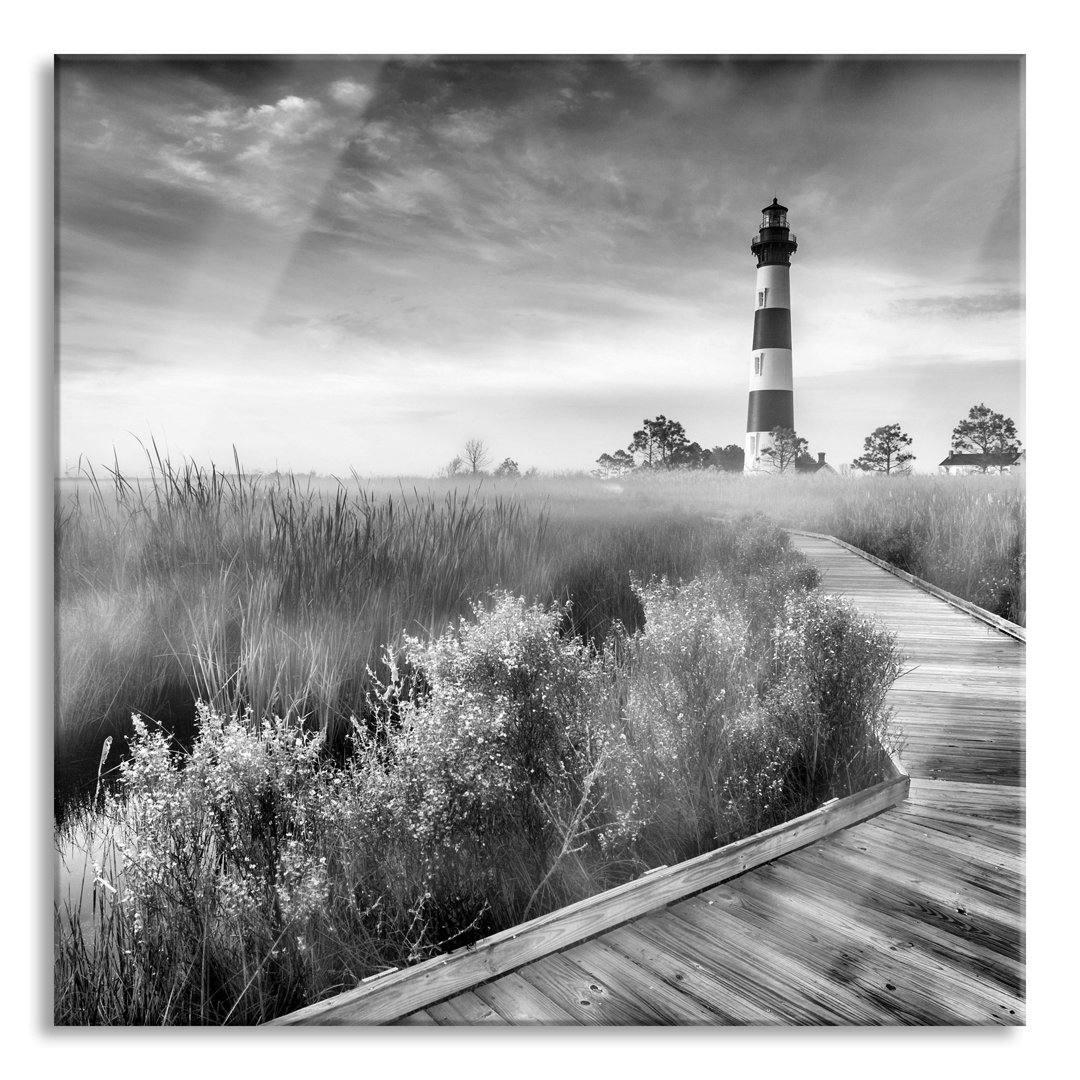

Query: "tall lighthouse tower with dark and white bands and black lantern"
left=744, top=198, right=798, bottom=472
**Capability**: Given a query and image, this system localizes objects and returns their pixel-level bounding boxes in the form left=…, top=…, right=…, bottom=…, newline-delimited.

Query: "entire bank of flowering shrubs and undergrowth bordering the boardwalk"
left=56, top=521, right=899, bottom=1024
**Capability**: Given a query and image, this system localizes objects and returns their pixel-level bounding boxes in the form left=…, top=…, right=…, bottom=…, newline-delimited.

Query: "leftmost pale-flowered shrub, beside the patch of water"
left=93, top=704, right=333, bottom=1022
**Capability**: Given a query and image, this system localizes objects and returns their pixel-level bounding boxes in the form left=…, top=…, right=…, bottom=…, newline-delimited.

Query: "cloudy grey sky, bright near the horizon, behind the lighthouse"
left=56, top=57, right=1026, bottom=475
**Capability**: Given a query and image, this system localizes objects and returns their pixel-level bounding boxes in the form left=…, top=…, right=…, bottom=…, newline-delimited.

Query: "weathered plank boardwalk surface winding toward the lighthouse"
left=274, top=537, right=1025, bottom=1025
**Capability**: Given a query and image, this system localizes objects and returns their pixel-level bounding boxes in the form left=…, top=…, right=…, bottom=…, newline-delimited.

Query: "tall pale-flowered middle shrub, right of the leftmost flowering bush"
left=352, top=593, right=610, bottom=936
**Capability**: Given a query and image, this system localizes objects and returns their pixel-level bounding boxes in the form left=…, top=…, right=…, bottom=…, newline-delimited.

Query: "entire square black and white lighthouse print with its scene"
left=50, top=39, right=1028, bottom=1042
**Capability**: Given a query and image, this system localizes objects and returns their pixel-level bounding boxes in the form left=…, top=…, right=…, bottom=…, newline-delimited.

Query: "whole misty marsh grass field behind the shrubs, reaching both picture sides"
left=55, top=457, right=1026, bottom=814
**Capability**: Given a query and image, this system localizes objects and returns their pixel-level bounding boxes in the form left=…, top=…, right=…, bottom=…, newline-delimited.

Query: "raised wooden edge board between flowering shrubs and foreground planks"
left=270, top=760, right=910, bottom=1026
